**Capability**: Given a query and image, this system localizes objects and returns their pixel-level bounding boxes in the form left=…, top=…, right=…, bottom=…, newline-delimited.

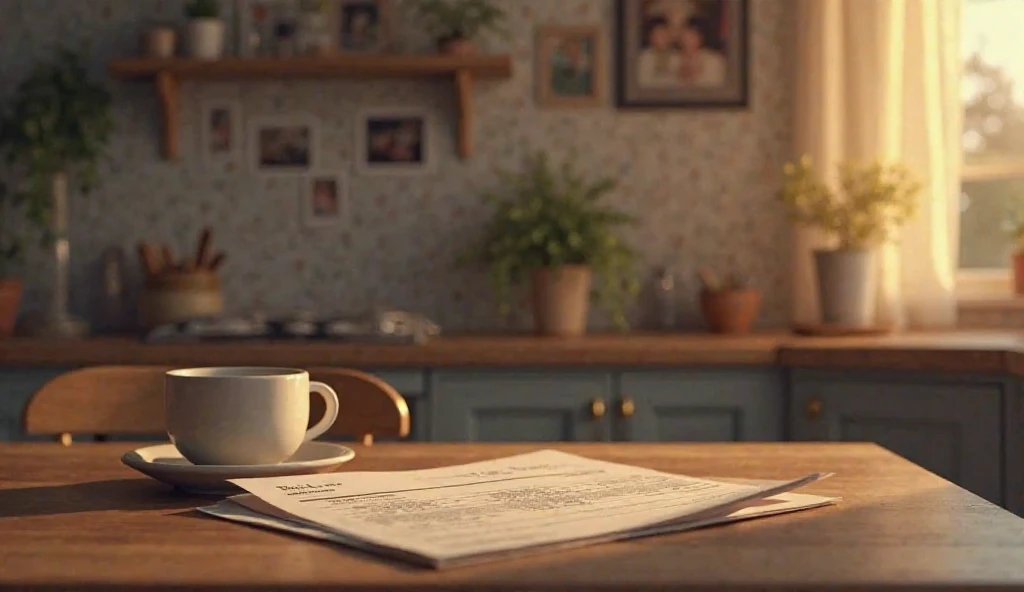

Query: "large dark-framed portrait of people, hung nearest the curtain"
left=615, top=0, right=750, bottom=109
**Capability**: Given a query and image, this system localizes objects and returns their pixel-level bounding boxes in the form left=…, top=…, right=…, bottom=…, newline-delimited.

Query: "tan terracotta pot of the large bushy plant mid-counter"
left=530, top=265, right=591, bottom=337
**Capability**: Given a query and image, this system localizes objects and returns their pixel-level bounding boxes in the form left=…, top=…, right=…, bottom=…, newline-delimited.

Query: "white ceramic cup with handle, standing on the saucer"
left=164, top=368, right=338, bottom=465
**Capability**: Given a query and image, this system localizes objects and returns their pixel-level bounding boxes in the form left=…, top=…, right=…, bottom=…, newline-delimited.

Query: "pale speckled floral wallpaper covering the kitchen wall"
left=0, top=0, right=792, bottom=331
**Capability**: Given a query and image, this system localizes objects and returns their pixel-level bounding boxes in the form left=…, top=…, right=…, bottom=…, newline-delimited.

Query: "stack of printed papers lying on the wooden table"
left=200, top=450, right=836, bottom=568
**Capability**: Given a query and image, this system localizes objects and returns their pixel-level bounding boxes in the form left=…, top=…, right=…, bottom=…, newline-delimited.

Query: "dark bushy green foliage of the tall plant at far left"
left=0, top=48, right=113, bottom=274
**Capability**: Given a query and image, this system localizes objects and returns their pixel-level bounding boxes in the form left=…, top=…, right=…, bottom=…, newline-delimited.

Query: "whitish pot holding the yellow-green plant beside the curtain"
left=814, top=250, right=878, bottom=327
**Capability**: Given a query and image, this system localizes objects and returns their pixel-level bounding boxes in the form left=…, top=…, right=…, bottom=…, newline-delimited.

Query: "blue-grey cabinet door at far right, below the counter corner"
left=791, top=372, right=1004, bottom=504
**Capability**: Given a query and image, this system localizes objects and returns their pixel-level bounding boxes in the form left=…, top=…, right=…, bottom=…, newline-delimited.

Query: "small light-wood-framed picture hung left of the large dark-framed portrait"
left=537, top=27, right=606, bottom=107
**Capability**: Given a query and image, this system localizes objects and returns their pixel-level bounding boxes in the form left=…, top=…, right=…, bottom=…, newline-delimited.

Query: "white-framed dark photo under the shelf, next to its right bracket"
left=355, top=109, right=435, bottom=175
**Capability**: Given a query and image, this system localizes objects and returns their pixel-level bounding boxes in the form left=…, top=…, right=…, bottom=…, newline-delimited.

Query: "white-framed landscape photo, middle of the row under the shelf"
left=248, top=117, right=319, bottom=174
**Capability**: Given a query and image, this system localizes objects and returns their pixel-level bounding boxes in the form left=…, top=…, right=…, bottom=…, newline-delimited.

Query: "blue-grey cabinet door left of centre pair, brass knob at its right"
left=430, top=371, right=611, bottom=441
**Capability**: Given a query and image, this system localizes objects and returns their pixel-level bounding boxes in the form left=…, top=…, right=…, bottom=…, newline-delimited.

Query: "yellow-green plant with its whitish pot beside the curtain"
left=780, top=156, right=922, bottom=328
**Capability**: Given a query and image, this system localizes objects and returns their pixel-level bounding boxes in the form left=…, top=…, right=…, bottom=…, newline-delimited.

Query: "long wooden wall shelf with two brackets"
left=108, top=55, right=512, bottom=160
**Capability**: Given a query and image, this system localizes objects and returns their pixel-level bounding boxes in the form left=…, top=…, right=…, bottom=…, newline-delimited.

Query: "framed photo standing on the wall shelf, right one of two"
left=333, top=0, right=395, bottom=53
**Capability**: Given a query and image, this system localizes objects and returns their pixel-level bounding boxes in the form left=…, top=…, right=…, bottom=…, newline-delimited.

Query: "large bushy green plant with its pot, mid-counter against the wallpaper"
left=459, top=152, right=638, bottom=336
